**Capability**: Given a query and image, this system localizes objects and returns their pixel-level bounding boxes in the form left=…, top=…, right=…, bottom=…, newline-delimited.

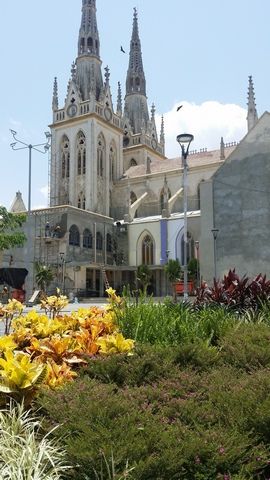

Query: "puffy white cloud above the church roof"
left=157, top=101, right=247, bottom=158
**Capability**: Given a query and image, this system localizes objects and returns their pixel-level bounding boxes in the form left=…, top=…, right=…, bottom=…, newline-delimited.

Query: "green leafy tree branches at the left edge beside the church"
left=0, top=206, right=26, bottom=252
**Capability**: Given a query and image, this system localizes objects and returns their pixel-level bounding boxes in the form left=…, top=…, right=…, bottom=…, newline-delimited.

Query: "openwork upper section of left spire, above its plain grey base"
left=78, top=0, right=100, bottom=58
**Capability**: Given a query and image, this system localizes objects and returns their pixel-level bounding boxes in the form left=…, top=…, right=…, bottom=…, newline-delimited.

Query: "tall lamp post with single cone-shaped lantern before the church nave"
left=176, top=133, right=194, bottom=300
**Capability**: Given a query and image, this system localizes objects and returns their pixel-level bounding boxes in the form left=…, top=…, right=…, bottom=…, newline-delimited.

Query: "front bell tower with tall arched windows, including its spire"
left=50, top=0, right=123, bottom=216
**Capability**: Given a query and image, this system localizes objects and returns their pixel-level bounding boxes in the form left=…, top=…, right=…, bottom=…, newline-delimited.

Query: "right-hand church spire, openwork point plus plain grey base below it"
left=125, top=8, right=149, bottom=134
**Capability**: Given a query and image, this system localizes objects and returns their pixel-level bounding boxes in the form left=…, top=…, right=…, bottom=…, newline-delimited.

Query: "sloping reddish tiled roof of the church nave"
left=125, top=142, right=237, bottom=178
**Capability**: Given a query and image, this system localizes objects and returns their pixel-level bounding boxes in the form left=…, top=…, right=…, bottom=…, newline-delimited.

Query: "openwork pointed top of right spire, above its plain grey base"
left=126, top=8, right=146, bottom=95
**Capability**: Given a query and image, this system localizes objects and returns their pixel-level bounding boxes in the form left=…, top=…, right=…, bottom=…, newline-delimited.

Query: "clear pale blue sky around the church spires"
left=0, top=0, right=270, bottom=207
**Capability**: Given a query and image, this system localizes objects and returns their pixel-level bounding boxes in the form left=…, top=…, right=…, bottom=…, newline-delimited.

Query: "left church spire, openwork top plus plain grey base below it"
left=76, top=0, right=103, bottom=101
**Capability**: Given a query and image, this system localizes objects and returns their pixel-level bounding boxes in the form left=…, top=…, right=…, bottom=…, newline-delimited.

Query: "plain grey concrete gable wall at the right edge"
left=201, top=112, right=270, bottom=280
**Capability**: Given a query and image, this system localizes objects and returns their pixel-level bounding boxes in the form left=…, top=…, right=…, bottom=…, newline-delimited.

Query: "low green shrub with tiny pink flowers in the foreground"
left=39, top=343, right=270, bottom=480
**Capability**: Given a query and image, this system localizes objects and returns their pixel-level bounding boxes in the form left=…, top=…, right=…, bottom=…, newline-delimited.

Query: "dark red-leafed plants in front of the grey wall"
left=195, top=269, right=270, bottom=311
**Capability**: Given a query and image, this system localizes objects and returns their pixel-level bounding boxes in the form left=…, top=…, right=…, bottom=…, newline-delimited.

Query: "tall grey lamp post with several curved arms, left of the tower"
left=10, top=130, right=51, bottom=297
